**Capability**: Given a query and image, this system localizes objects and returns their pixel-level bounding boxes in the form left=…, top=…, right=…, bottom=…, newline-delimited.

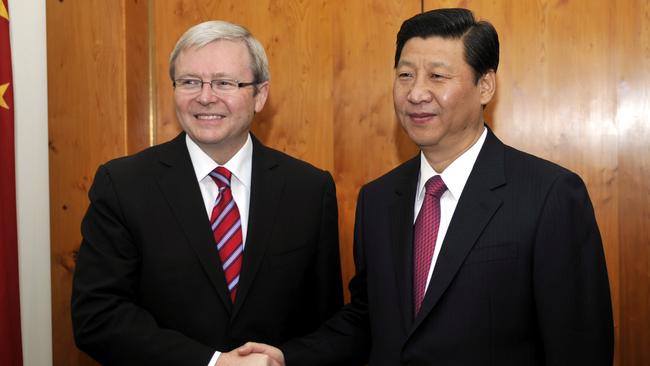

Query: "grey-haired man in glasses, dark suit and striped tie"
left=72, top=21, right=342, bottom=366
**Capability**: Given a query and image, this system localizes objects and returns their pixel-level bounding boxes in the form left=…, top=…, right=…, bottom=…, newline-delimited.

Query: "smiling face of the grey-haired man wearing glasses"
left=174, top=40, right=269, bottom=164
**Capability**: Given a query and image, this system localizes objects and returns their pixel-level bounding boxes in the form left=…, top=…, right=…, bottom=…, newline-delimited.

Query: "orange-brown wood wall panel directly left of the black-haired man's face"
left=332, top=0, right=420, bottom=298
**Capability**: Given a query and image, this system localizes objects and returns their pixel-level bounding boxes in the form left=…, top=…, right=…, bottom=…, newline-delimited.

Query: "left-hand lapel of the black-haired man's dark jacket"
left=389, top=155, right=420, bottom=330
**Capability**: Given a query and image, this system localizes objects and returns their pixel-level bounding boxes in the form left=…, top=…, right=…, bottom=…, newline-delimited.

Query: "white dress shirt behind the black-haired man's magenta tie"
left=413, top=128, right=487, bottom=288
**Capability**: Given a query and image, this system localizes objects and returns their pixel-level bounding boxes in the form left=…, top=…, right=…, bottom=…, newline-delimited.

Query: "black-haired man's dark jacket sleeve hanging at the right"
left=533, top=173, right=614, bottom=365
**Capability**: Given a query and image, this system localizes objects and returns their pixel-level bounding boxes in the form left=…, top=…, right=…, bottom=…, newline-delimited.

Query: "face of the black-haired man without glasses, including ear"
left=393, top=37, right=495, bottom=172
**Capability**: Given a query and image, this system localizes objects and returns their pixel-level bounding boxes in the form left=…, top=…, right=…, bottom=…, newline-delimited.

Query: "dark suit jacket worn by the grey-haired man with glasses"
left=72, top=134, right=343, bottom=366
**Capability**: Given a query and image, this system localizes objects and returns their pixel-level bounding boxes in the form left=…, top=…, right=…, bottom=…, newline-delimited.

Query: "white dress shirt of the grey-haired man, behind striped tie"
left=185, top=134, right=253, bottom=366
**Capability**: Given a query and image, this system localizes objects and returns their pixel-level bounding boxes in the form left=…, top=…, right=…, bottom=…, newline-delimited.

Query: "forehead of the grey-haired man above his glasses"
left=176, top=39, right=252, bottom=77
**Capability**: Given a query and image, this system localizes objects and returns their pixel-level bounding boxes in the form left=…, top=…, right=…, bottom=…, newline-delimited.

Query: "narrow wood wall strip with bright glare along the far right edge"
left=610, top=0, right=650, bottom=366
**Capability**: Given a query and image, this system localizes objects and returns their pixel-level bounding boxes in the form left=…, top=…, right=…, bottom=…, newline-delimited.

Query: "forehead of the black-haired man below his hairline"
left=398, top=36, right=469, bottom=67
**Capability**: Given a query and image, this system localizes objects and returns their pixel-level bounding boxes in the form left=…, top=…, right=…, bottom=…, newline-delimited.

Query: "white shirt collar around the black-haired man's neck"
left=417, top=127, right=487, bottom=200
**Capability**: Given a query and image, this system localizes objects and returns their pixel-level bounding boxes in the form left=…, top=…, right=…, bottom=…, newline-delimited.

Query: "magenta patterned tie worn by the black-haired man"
left=413, top=175, right=447, bottom=316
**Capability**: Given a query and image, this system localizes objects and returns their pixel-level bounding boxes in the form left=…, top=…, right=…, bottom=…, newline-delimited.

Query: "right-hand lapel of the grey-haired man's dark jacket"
left=233, top=137, right=284, bottom=318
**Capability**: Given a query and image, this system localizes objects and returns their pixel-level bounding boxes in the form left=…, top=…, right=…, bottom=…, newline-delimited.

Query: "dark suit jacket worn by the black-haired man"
left=282, top=128, right=613, bottom=366
